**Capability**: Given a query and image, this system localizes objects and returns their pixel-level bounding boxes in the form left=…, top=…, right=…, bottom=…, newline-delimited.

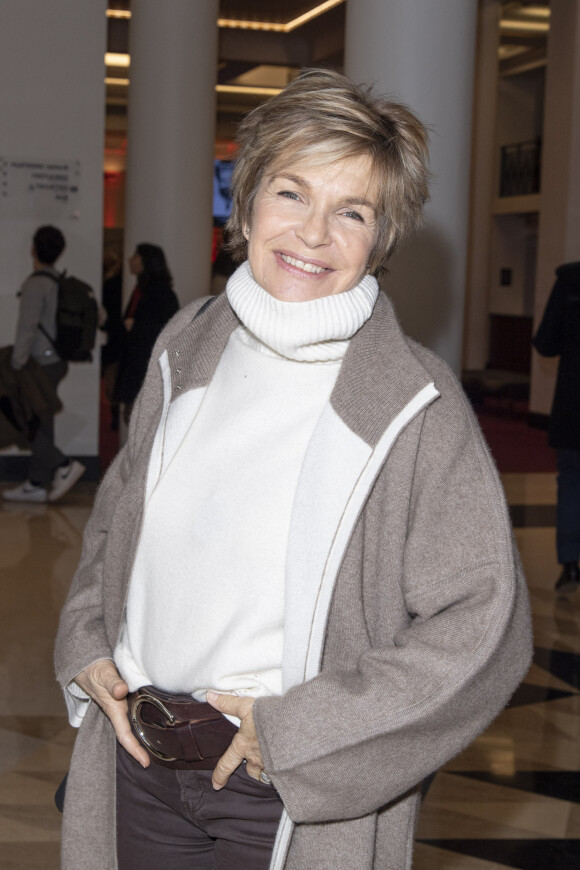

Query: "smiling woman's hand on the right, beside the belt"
left=207, top=692, right=264, bottom=791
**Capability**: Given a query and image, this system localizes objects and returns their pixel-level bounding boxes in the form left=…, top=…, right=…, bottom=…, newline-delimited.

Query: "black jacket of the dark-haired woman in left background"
left=115, top=282, right=179, bottom=405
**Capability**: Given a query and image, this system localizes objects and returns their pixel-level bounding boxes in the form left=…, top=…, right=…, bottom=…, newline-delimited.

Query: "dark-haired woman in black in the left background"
left=115, top=242, right=179, bottom=422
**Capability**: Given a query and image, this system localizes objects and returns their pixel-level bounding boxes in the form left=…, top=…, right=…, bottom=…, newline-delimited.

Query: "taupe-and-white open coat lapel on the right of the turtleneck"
left=283, top=293, right=438, bottom=691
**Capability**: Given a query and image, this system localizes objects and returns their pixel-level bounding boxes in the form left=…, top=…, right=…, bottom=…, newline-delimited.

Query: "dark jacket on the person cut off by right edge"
left=534, top=262, right=580, bottom=450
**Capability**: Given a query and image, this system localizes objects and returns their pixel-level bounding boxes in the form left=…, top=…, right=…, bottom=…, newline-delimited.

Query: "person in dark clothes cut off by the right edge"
left=533, top=262, right=580, bottom=593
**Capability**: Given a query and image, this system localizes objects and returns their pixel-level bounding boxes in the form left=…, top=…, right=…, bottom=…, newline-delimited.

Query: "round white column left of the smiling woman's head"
left=125, top=0, right=218, bottom=304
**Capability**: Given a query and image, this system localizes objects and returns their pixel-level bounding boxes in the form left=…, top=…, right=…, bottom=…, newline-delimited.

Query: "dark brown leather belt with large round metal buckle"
left=128, top=686, right=238, bottom=770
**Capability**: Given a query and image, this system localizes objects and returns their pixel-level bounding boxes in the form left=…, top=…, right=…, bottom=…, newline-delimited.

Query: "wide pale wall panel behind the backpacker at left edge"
left=0, top=0, right=107, bottom=477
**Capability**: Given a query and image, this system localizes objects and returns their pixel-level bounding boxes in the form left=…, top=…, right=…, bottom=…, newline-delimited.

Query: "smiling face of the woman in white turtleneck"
left=247, top=155, right=378, bottom=302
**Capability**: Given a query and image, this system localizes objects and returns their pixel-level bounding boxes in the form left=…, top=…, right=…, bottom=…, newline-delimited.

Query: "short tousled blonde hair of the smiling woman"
left=227, top=69, right=429, bottom=274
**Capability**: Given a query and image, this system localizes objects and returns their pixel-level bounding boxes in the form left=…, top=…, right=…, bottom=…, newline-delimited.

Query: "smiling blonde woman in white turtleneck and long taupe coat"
left=57, top=70, right=530, bottom=870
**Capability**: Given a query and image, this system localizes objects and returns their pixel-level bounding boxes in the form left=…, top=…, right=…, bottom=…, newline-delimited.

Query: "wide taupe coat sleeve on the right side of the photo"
left=254, top=366, right=531, bottom=823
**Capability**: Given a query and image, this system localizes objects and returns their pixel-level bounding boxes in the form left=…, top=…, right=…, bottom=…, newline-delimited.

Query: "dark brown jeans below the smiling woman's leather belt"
left=117, top=745, right=282, bottom=870
